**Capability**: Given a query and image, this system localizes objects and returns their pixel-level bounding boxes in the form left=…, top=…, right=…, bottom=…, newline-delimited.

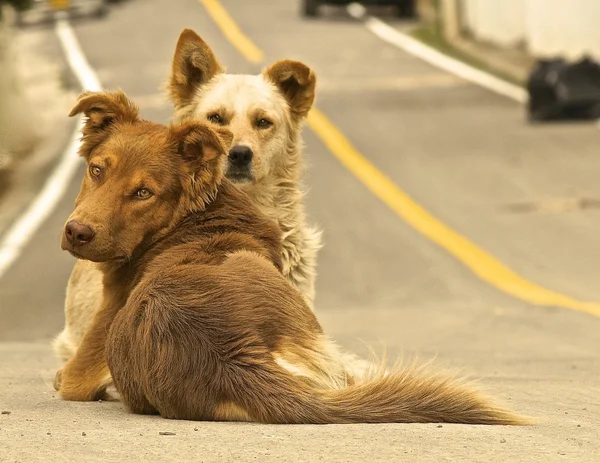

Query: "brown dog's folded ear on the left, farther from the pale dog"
left=69, top=90, right=139, bottom=156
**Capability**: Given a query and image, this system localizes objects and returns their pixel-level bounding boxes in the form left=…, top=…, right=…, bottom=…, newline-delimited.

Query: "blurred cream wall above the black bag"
left=454, top=0, right=600, bottom=59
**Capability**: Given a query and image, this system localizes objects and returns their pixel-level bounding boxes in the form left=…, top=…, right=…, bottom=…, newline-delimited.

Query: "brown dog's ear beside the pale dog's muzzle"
left=171, top=122, right=233, bottom=212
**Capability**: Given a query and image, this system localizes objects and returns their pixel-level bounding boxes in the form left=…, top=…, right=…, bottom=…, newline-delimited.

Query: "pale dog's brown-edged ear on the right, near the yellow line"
left=263, top=60, right=317, bottom=119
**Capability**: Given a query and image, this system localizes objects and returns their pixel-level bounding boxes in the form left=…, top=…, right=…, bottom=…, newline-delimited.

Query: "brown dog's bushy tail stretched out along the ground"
left=227, top=358, right=529, bottom=425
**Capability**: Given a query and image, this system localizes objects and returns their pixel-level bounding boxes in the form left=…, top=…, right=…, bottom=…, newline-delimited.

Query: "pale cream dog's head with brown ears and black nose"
left=168, top=29, right=316, bottom=184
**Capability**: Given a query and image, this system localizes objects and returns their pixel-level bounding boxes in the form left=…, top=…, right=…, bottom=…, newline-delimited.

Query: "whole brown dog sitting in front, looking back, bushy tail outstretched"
left=58, top=92, right=523, bottom=424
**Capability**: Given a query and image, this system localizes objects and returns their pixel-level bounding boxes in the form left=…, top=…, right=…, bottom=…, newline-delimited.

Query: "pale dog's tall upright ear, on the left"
left=168, top=29, right=223, bottom=107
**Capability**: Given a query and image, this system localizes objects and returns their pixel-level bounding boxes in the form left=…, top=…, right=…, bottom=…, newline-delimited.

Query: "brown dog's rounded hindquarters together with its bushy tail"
left=108, top=239, right=523, bottom=424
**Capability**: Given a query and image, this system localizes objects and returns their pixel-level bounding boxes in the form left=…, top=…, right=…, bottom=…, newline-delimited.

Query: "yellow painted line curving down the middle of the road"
left=200, top=0, right=600, bottom=317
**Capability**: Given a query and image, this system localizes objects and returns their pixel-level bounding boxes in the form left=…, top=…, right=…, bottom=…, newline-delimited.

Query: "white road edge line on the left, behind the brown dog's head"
left=0, top=19, right=102, bottom=278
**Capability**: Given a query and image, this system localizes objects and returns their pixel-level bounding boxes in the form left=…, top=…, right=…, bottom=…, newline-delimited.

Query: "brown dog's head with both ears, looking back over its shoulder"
left=61, top=91, right=230, bottom=262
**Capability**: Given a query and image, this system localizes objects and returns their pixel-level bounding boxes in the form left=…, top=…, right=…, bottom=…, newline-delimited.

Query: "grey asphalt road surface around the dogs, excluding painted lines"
left=0, top=0, right=600, bottom=462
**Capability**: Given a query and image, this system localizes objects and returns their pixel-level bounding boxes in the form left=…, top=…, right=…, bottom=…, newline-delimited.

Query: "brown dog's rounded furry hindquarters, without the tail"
left=107, top=251, right=321, bottom=420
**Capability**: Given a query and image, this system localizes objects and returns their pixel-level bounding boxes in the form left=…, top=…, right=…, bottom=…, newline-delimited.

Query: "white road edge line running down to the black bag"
left=347, top=3, right=527, bottom=103
